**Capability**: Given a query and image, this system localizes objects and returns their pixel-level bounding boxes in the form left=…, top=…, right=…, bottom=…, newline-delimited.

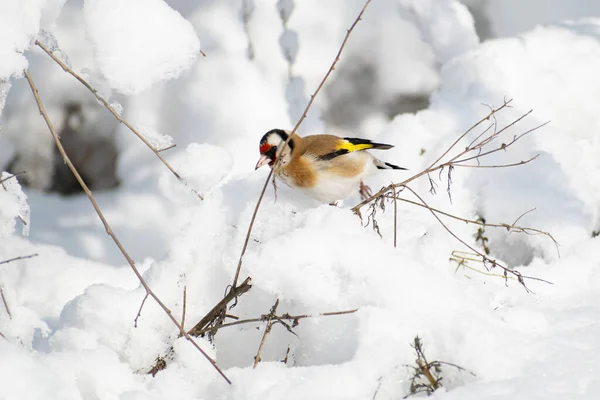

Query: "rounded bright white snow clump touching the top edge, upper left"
left=83, top=0, right=200, bottom=94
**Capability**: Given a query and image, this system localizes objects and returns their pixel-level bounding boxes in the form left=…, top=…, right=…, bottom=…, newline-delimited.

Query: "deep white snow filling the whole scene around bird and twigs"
left=0, top=0, right=600, bottom=400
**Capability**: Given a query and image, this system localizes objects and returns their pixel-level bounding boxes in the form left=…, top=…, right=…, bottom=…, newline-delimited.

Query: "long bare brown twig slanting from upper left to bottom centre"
left=24, top=71, right=231, bottom=384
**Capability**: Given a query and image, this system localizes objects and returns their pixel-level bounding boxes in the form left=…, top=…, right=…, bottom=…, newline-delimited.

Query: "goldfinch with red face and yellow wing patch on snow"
left=255, top=129, right=406, bottom=204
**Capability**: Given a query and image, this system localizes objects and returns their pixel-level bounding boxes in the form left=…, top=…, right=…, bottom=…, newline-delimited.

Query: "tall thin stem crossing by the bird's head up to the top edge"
left=231, top=0, right=371, bottom=288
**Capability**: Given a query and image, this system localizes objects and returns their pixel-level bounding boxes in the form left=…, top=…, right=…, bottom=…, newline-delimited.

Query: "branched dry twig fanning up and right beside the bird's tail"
left=352, top=99, right=548, bottom=212
